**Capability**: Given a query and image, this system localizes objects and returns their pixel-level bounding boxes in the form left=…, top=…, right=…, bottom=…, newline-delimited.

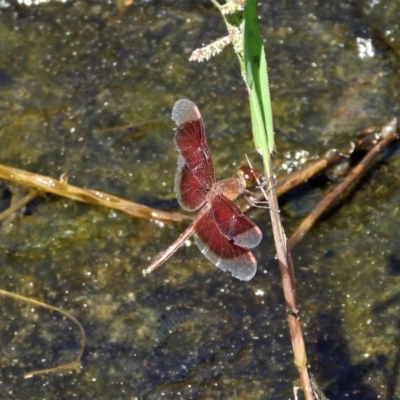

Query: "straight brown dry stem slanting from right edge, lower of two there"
left=288, top=133, right=398, bottom=250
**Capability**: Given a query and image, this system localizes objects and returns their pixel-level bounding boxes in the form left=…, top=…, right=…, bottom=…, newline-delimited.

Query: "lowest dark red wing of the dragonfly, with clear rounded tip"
left=194, top=210, right=257, bottom=281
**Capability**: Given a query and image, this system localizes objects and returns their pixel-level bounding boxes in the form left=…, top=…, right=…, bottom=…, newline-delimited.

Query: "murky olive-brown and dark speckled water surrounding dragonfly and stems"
left=0, top=0, right=400, bottom=400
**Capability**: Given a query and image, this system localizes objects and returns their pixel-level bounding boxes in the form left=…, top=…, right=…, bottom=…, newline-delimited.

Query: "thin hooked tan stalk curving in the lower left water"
left=0, top=289, right=86, bottom=379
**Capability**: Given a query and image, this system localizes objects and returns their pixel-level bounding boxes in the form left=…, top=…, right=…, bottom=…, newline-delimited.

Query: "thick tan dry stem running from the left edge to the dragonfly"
left=0, top=164, right=192, bottom=222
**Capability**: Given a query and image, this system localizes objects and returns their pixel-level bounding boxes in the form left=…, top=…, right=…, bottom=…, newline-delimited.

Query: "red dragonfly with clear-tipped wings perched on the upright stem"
left=143, top=100, right=262, bottom=281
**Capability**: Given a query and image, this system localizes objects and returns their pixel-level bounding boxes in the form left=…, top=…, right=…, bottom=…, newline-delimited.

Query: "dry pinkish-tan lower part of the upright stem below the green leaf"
left=264, top=158, right=314, bottom=400
